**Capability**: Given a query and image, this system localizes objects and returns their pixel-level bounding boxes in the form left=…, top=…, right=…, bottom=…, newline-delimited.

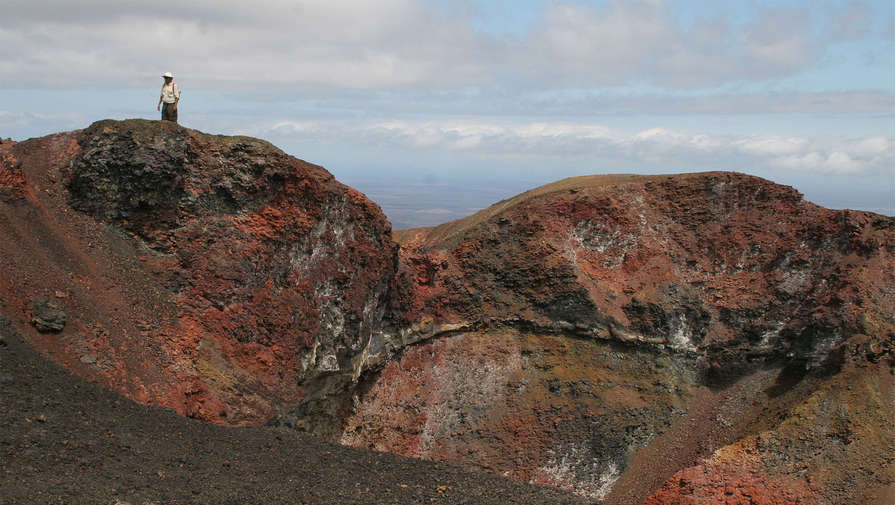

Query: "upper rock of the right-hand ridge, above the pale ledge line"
left=399, top=173, right=895, bottom=374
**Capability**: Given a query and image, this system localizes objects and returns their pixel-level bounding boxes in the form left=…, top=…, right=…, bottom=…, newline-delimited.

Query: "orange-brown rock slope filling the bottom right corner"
left=645, top=354, right=895, bottom=505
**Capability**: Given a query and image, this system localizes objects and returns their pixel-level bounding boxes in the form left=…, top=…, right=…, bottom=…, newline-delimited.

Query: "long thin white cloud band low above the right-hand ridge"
left=250, top=119, right=895, bottom=175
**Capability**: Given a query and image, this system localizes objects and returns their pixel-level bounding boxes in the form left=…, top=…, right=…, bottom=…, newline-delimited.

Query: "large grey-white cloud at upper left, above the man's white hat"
left=0, top=0, right=496, bottom=88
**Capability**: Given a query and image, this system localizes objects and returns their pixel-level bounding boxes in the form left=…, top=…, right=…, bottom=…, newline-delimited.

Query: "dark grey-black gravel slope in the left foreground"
left=0, top=317, right=588, bottom=505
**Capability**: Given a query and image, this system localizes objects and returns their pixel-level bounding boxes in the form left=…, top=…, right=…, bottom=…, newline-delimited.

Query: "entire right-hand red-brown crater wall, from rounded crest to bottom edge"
left=341, top=173, right=895, bottom=504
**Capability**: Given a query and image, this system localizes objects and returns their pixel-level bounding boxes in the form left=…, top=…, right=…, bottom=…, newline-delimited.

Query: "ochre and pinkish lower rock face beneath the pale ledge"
left=340, top=328, right=698, bottom=498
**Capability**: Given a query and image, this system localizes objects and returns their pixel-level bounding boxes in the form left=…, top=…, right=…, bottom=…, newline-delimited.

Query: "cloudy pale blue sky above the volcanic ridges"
left=0, top=0, right=895, bottom=224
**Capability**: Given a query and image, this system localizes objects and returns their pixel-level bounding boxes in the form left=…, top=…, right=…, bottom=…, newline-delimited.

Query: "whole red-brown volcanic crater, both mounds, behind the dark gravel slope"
left=0, top=120, right=895, bottom=505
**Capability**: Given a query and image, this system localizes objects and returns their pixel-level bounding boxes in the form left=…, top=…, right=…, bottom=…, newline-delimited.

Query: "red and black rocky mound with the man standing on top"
left=0, top=120, right=397, bottom=424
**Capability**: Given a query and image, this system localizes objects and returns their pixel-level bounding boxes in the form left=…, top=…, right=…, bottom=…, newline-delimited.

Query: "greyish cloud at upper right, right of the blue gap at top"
left=523, top=0, right=825, bottom=88
